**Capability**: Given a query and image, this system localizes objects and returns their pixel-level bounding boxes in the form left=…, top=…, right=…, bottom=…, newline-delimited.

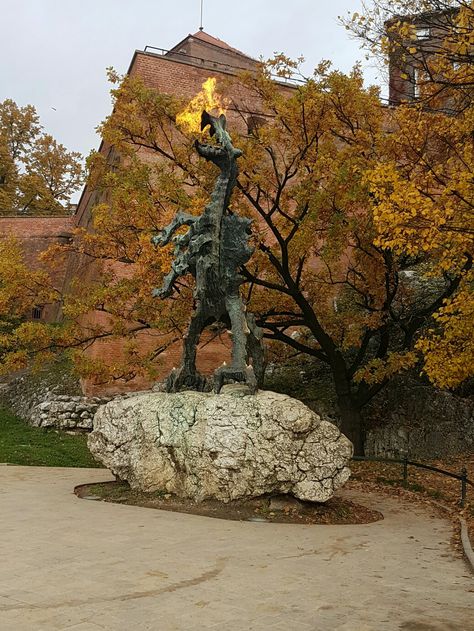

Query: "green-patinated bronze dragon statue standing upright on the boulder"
left=152, top=112, right=264, bottom=392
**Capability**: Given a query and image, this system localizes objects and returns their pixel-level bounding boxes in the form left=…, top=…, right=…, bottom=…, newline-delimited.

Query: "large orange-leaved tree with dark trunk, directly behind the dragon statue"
left=0, top=56, right=466, bottom=453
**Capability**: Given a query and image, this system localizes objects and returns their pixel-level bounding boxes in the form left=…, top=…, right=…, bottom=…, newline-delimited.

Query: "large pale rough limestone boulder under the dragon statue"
left=88, top=385, right=352, bottom=502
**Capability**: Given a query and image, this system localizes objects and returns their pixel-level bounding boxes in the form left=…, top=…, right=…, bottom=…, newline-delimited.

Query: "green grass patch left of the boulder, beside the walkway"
left=0, top=408, right=101, bottom=467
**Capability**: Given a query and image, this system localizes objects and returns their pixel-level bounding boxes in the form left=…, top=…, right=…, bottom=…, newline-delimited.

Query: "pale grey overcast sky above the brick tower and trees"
left=0, top=0, right=378, bottom=163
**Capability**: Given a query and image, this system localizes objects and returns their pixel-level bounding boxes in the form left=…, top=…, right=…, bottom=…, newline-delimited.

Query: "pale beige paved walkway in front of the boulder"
left=0, top=466, right=474, bottom=631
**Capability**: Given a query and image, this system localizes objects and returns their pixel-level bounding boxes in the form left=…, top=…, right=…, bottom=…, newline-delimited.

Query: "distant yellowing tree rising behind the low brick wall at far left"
left=0, top=99, right=83, bottom=216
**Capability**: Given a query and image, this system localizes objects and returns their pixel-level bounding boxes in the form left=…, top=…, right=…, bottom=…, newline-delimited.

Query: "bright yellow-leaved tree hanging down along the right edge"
left=348, top=0, right=474, bottom=388
